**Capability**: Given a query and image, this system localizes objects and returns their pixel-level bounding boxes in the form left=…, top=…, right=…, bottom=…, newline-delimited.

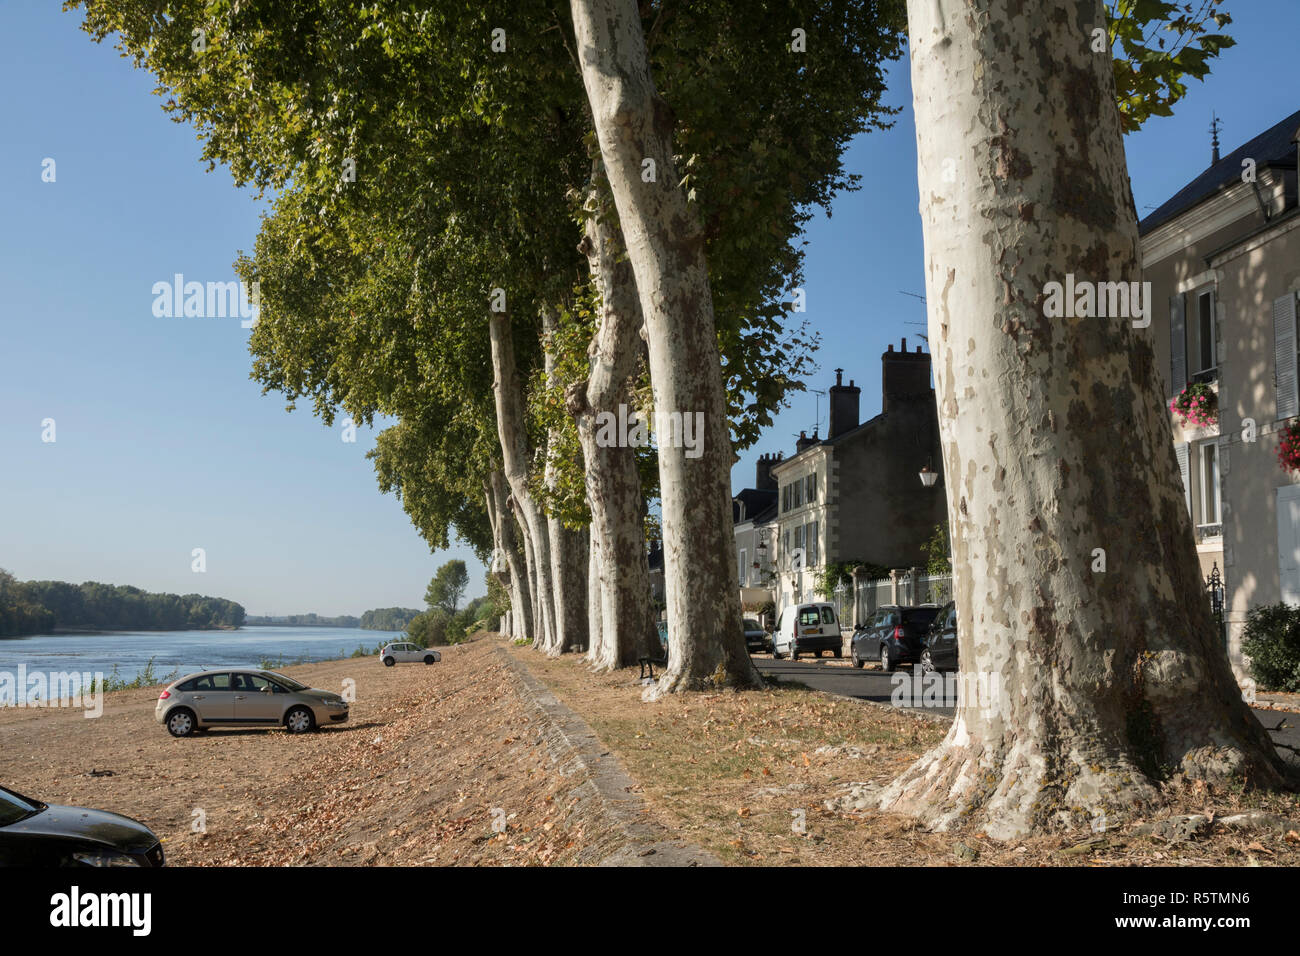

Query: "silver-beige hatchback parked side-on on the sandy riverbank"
left=153, top=669, right=347, bottom=737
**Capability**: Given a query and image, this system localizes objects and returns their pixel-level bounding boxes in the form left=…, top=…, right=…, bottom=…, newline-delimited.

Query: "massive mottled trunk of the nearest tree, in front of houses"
left=881, top=0, right=1282, bottom=839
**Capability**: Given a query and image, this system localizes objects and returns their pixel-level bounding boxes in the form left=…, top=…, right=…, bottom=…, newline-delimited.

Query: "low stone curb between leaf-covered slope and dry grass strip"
left=494, top=646, right=723, bottom=866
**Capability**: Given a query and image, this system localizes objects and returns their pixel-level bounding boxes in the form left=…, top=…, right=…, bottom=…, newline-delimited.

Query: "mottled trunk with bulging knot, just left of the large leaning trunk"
left=566, top=179, right=658, bottom=671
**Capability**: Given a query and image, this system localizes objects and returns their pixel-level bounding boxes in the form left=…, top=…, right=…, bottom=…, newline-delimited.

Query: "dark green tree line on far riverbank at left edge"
left=0, top=570, right=244, bottom=637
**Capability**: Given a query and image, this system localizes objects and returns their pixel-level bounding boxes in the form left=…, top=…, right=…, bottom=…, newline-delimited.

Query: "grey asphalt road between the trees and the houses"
left=754, top=657, right=1300, bottom=767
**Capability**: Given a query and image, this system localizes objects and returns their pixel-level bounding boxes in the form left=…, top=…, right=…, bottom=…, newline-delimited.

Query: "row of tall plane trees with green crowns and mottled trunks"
left=74, top=0, right=1279, bottom=834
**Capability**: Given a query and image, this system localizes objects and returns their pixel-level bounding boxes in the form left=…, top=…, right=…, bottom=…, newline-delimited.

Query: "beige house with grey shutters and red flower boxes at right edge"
left=1139, top=112, right=1300, bottom=671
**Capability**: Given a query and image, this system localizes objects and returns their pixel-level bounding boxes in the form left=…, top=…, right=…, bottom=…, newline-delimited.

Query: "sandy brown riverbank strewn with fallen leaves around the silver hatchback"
left=0, top=640, right=605, bottom=865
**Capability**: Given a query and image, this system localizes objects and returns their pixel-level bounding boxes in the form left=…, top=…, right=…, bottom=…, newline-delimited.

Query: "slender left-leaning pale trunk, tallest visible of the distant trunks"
left=489, top=312, right=556, bottom=652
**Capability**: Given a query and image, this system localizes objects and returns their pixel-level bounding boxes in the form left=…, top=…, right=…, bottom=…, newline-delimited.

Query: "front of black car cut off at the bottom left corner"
left=0, top=787, right=164, bottom=866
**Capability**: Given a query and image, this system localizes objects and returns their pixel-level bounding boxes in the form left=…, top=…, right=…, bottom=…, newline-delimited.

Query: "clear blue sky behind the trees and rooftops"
left=0, top=0, right=1300, bottom=614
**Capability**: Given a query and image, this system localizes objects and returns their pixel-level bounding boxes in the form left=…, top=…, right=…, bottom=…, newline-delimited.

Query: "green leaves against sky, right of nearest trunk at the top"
left=1106, top=0, right=1236, bottom=133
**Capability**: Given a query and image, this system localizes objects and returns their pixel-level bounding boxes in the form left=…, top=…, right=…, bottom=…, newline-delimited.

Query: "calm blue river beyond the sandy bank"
left=0, top=627, right=397, bottom=693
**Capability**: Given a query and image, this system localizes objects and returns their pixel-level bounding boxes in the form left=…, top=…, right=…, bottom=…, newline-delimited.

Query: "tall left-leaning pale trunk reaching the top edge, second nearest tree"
left=571, top=0, right=762, bottom=697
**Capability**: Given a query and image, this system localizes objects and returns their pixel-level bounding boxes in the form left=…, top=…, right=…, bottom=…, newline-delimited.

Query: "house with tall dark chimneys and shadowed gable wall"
left=770, top=338, right=946, bottom=613
